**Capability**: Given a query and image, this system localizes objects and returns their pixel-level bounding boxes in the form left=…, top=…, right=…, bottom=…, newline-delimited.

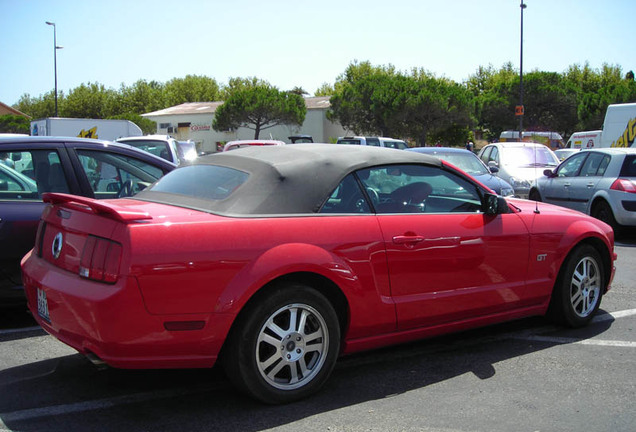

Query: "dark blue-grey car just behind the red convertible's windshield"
left=409, top=147, right=515, bottom=196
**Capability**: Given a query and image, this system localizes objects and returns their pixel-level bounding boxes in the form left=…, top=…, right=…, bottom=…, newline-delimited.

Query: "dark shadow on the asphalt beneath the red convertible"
left=0, top=311, right=612, bottom=432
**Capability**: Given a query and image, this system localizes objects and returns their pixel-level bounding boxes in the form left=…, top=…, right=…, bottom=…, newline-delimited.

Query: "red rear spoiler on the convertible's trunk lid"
left=42, top=192, right=152, bottom=222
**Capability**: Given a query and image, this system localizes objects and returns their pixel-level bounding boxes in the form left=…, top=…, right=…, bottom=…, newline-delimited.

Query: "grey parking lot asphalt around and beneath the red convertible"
left=0, top=239, right=636, bottom=432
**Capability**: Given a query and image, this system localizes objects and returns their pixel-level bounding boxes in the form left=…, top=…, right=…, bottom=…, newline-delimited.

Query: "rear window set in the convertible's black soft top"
left=149, top=165, right=249, bottom=200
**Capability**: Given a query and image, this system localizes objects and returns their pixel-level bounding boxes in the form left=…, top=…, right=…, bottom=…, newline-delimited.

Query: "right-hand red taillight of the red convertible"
left=79, top=236, right=122, bottom=283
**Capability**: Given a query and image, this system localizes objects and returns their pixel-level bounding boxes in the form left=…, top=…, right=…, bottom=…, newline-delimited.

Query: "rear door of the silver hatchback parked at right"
left=569, top=152, right=611, bottom=213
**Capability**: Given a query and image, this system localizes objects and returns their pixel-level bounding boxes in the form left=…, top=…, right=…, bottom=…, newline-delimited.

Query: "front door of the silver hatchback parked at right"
left=540, top=152, right=588, bottom=210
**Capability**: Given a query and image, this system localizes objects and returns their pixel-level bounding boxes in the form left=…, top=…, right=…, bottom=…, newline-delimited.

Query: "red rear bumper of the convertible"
left=22, top=253, right=233, bottom=369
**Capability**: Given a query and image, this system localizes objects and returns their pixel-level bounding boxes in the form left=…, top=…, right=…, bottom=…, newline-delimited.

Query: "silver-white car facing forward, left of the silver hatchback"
left=479, top=142, right=559, bottom=198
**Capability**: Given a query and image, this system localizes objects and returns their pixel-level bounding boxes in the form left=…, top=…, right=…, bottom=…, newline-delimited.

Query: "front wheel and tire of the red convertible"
left=548, top=245, right=605, bottom=327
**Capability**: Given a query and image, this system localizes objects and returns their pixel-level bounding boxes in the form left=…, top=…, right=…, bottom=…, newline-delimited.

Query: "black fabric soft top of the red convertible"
left=135, top=144, right=442, bottom=216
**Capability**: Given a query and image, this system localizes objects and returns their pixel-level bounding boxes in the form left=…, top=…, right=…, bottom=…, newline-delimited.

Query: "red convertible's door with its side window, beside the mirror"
left=360, top=165, right=531, bottom=329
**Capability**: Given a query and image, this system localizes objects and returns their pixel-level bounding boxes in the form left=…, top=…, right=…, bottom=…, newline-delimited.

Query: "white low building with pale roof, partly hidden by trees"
left=143, top=97, right=351, bottom=152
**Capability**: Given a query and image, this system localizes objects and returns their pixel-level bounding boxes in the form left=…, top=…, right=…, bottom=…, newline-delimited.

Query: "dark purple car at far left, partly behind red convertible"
left=0, top=136, right=175, bottom=306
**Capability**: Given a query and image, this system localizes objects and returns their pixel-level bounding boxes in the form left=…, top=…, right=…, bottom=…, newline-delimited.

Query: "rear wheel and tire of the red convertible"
left=224, top=284, right=340, bottom=404
